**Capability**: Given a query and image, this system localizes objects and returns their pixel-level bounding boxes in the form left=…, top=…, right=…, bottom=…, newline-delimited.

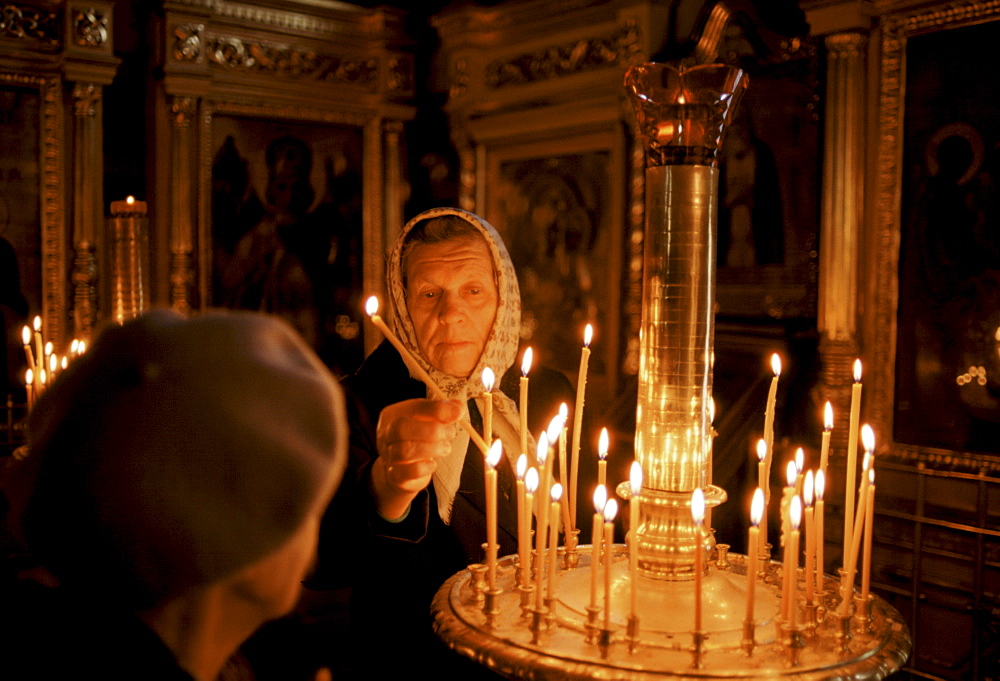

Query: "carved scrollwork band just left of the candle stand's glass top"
left=486, top=25, right=641, bottom=88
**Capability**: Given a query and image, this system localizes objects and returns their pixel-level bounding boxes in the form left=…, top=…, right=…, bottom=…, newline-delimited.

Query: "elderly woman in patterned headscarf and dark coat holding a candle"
left=317, top=208, right=573, bottom=678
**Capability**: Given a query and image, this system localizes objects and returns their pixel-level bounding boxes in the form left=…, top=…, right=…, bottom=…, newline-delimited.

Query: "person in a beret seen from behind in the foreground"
left=0, top=311, right=347, bottom=681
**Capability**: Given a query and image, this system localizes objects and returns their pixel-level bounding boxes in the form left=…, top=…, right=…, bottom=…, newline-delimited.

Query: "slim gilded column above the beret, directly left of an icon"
left=170, top=96, right=197, bottom=314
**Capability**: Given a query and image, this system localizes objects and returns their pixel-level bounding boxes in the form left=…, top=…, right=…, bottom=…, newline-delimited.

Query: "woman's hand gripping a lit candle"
left=372, top=399, right=462, bottom=519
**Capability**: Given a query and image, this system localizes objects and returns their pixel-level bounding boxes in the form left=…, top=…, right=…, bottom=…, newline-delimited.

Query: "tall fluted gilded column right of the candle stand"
left=817, top=32, right=868, bottom=451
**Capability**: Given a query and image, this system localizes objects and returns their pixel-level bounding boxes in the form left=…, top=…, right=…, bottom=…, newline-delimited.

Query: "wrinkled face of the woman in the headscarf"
left=406, top=237, right=498, bottom=378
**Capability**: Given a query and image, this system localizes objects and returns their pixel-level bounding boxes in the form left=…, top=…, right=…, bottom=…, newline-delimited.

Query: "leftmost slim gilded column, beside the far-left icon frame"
left=72, top=83, right=104, bottom=338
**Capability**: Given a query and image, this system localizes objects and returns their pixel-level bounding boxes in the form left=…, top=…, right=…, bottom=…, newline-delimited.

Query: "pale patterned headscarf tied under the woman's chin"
left=386, top=208, right=534, bottom=523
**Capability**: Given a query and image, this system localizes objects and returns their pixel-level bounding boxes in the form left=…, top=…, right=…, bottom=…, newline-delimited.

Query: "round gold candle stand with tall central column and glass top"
left=432, top=64, right=911, bottom=679
